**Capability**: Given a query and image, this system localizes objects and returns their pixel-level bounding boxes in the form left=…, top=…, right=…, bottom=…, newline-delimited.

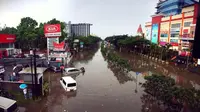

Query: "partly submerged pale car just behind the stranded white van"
left=63, top=67, right=85, bottom=75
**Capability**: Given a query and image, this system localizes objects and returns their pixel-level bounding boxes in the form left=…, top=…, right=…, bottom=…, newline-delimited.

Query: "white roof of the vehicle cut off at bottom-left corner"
left=0, top=96, right=16, bottom=109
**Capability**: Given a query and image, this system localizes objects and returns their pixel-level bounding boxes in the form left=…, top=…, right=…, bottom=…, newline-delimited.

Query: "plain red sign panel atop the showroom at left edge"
left=0, top=34, right=16, bottom=43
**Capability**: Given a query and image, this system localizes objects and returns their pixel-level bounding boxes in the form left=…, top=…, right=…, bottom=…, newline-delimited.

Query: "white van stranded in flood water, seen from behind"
left=60, top=77, right=77, bottom=91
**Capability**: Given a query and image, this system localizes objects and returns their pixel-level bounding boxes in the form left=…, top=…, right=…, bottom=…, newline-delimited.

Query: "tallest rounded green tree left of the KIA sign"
left=17, top=17, right=38, bottom=49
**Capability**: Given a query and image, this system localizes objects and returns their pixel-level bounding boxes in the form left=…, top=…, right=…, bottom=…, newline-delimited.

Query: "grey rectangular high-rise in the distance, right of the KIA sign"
left=67, top=22, right=92, bottom=37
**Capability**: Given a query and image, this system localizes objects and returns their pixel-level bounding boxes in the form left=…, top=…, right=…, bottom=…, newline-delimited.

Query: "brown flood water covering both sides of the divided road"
left=32, top=46, right=200, bottom=112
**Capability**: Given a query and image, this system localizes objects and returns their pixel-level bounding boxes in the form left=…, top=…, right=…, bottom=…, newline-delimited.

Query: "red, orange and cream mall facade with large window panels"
left=145, top=4, right=198, bottom=50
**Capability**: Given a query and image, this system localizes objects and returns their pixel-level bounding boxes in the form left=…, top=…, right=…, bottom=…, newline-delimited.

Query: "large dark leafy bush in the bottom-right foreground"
left=142, top=74, right=200, bottom=112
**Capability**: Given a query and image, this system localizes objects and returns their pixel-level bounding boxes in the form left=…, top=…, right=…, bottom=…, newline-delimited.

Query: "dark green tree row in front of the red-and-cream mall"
left=105, top=35, right=178, bottom=61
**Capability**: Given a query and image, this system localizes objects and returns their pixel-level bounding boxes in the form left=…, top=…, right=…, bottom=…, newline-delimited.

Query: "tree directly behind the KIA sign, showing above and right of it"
left=47, top=18, right=67, bottom=42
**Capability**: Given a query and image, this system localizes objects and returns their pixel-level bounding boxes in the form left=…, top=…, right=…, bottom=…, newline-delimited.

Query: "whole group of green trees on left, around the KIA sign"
left=0, top=17, right=67, bottom=50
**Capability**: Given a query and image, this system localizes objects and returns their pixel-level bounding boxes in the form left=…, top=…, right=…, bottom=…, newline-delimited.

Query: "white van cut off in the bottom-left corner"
left=0, top=96, right=19, bottom=112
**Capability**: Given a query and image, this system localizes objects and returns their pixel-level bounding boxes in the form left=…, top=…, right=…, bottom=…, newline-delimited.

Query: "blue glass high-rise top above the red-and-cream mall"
left=156, top=0, right=196, bottom=16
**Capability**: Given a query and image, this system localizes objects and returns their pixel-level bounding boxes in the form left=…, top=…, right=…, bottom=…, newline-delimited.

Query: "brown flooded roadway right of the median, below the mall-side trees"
left=119, top=53, right=200, bottom=89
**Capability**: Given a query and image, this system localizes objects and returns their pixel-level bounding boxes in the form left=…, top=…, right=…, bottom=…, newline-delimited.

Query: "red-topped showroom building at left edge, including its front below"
left=0, top=34, right=16, bottom=58
